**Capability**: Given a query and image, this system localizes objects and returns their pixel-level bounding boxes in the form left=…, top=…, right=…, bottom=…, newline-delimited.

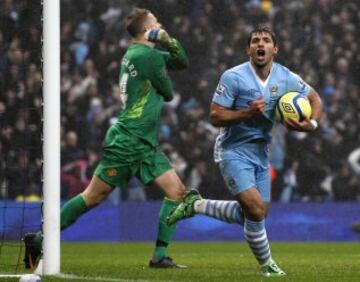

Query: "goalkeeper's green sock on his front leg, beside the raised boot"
left=152, top=198, right=179, bottom=262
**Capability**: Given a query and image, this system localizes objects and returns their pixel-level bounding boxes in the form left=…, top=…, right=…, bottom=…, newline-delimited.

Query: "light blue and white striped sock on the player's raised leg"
left=194, top=199, right=244, bottom=225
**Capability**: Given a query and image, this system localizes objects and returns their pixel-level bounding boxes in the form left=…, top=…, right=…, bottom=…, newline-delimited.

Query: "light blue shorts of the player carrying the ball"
left=218, top=142, right=271, bottom=202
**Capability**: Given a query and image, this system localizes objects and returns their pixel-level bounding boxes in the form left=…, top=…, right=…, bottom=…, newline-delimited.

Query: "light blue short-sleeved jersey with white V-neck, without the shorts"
left=212, top=62, right=311, bottom=162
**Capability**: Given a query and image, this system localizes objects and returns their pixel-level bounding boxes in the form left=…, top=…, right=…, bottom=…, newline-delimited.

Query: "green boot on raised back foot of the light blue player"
left=166, top=189, right=202, bottom=225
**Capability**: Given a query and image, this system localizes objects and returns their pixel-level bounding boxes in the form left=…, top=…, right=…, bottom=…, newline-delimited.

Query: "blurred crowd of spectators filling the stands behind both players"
left=0, top=0, right=360, bottom=202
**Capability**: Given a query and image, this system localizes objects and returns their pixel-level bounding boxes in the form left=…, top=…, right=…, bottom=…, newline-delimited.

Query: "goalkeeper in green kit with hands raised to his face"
left=24, top=8, right=188, bottom=268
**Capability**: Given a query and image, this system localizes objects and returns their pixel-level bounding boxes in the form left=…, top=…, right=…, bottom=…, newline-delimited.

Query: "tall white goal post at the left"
left=42, top=0, right=60, bottom=275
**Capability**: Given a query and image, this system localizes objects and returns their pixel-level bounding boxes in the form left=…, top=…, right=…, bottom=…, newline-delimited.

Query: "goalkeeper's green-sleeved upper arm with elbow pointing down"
left=147, top=50, right=174, bottom=102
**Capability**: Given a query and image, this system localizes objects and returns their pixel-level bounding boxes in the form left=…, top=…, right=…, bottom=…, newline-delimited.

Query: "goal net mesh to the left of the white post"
left=0, top=0, right=42, bottom=274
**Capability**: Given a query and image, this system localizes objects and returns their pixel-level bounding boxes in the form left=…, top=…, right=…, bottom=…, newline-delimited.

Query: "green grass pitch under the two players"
left=0, top=242, right=360, bottom=282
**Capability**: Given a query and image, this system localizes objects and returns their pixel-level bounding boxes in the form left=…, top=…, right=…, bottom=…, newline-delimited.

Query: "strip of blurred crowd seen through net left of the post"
left=0, top=0, right=42, bottom=200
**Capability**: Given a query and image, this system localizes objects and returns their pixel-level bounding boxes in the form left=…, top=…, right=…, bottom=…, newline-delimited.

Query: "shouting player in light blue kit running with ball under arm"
left=169, top=27, right=322, bottom=276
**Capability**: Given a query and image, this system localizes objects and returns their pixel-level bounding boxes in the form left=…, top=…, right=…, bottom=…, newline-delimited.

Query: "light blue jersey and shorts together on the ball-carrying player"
left=213, top=62, right=311, bottom=202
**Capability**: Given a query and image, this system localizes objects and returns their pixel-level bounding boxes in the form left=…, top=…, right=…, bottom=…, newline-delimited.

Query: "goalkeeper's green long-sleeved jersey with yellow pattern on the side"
left=118, top=38, right=188, bottom=146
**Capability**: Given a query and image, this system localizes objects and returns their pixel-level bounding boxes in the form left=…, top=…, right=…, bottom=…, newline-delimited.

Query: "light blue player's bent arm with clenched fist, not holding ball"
left=210, top=72, right=265, bottom=127
